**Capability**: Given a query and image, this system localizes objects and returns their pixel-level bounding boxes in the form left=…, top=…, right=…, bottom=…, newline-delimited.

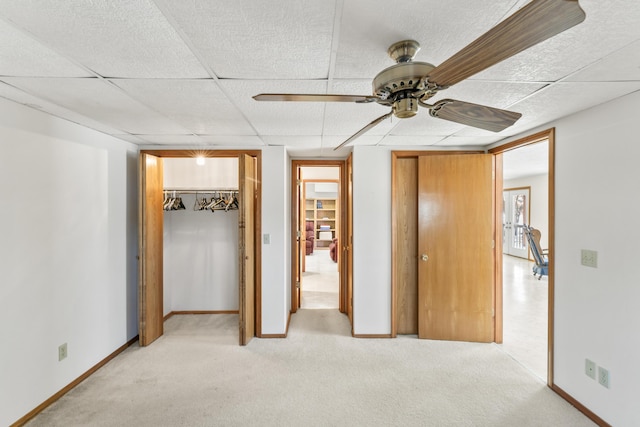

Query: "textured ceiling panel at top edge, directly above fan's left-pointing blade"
left=157, top=0, right=335, bottom=79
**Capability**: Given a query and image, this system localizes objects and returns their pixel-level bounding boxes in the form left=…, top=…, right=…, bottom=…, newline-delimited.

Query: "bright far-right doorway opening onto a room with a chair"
left=496, top=132, right=553, bottom=383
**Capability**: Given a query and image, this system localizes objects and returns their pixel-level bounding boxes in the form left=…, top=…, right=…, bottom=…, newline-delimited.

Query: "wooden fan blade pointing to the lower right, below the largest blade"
left=429, top=99, right=522, bottom=132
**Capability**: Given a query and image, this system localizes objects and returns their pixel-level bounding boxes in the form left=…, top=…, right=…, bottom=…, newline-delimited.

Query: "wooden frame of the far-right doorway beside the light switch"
left=488, top=128, right=555, bottom=388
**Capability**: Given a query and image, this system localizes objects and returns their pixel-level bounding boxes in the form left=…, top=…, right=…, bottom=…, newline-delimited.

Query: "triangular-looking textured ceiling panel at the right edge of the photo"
left=566, top=40, right=640, bottom=82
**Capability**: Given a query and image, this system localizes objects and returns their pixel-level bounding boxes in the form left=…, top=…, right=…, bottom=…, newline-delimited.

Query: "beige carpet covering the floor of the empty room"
left=29, top=310, right=594, bottom=426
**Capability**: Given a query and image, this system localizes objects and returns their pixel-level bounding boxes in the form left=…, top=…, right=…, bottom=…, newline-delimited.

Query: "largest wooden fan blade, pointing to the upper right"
left=428, top=0, right=585, bottom=87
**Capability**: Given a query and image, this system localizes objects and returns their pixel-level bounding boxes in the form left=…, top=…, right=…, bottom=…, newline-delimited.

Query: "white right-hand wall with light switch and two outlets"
left=498, top=92, right=640, bottom=426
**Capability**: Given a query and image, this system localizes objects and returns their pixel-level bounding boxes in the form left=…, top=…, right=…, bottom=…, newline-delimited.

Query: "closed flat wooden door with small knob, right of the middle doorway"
left=418, top=154, right=494, bottom=342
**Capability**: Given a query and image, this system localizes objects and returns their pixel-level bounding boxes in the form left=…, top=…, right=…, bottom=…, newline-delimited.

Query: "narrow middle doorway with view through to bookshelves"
left=291, top=160, right=351, bottom=332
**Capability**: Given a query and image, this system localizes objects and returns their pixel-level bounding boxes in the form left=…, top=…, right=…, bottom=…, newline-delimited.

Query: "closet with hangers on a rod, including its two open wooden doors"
left=139, top=150, right=261, bottom=346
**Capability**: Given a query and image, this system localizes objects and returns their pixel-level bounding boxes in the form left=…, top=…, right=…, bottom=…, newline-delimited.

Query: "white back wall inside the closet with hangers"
left=163, top=157, right=240, bottom=315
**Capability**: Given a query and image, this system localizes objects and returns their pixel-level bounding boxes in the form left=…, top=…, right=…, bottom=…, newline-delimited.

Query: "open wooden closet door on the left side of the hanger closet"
left=138, top=153, right=163, bottom=346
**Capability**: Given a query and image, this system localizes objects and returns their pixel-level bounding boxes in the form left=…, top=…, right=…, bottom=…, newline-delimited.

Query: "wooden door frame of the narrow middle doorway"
left=287, top=160, right=352, bottom=320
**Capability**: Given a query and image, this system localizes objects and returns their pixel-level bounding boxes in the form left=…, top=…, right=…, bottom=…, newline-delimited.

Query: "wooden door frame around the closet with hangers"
left=138, top=149, right=262, bottom=346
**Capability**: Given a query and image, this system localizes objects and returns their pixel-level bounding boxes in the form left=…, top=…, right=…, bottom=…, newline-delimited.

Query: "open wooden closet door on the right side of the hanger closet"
left=238, top=154, right=257, bottom=345
